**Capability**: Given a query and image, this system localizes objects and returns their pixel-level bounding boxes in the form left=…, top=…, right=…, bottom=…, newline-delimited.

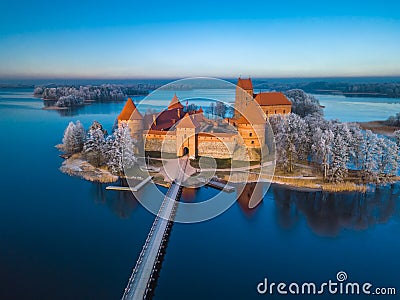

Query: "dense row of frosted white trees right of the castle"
left=269, top=90, right=400, bottom=183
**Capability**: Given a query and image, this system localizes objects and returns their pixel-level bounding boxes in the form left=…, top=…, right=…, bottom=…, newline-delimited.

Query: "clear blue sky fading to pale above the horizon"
left=0, top=0, right=400, bottom=79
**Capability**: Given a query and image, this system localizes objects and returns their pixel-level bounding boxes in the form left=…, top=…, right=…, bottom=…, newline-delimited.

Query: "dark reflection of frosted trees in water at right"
left=273, top=184, right=400, bottom=236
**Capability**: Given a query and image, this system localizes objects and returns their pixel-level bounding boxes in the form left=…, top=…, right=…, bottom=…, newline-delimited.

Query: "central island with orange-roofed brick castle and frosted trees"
left=58, top=78, right=400, bottom=192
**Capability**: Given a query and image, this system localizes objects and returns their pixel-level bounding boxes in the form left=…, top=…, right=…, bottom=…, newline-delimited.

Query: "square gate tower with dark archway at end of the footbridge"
left=176, top=113, right=200, bottom=157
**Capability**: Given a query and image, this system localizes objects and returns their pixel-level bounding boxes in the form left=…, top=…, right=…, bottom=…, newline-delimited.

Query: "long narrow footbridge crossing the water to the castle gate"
left=122, top=157, right=187, bottom=300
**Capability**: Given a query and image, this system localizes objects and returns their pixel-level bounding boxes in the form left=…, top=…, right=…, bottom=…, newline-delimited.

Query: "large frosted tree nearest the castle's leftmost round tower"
left=107, top=123, right=137, bottom=175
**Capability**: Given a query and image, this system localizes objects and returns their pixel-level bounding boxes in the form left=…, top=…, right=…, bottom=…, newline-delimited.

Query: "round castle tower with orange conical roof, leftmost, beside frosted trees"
left=118, top=98, right=143, bottom=141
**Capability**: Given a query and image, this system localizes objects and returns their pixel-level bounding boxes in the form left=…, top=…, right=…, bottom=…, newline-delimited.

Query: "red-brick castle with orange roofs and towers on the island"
left=118, top=78, right=292, bottom=161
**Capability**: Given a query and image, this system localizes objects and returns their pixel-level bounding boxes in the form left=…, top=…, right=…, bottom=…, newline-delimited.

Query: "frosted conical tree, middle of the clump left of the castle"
left=83, top=121, right=106, bottom=167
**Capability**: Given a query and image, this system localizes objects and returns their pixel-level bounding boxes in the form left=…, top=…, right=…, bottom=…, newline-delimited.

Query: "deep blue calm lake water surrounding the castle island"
left=0, top=89, right=400, bottom=299
